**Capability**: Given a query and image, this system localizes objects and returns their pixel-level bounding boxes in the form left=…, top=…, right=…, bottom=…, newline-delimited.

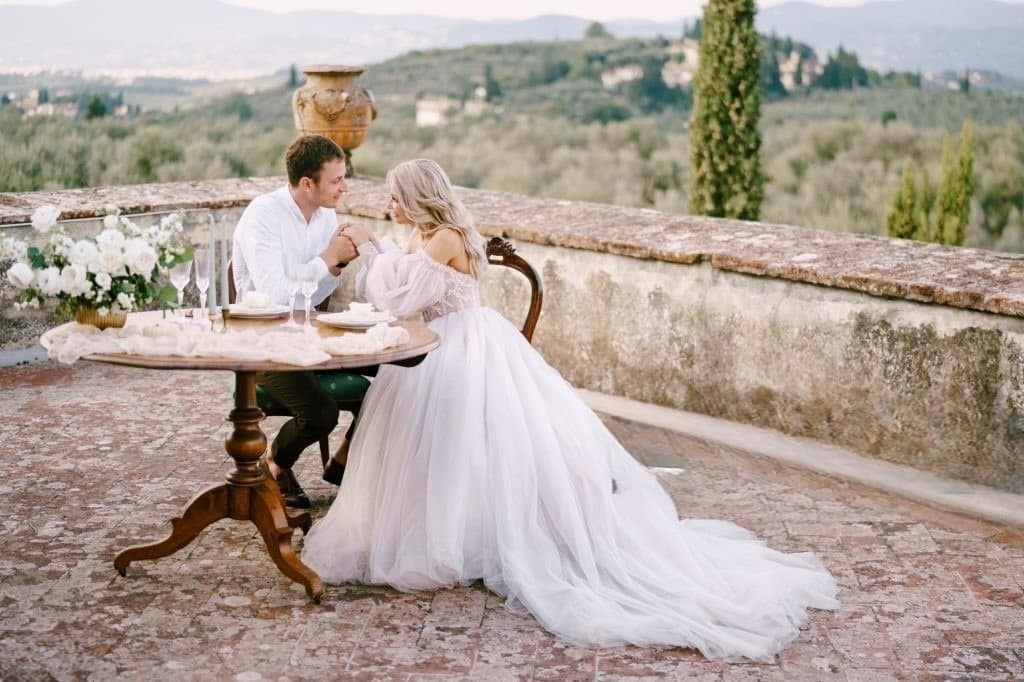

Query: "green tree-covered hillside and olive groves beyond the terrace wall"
left=0, top=35, right=1024, bottom=251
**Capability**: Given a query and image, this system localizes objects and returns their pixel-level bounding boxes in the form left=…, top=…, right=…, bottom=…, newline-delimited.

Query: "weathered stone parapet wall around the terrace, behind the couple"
left=0, top=178, right=1024, bottom=492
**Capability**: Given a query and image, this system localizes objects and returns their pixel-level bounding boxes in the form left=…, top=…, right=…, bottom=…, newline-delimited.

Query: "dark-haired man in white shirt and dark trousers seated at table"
left=231, top=135, right=358, bottom=509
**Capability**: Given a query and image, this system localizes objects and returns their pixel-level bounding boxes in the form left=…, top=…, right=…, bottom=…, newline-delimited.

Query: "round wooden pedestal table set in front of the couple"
left=41, top=311, right=440, bottom=602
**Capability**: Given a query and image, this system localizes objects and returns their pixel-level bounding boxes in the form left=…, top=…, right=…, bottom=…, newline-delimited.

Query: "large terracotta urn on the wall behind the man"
left=292, top=65, right=377, bottom=175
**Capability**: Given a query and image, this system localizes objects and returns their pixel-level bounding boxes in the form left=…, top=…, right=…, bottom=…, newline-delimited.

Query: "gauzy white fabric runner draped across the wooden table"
left=41, top=321, right=409, bottom=367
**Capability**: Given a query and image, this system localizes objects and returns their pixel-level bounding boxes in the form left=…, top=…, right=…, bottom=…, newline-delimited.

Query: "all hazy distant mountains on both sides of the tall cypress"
left=6, top=0, right=1024, bottom=78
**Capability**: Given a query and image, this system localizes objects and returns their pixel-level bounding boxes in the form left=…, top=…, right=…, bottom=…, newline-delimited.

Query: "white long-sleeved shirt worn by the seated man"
left=231, top=185, right=340, bottom=308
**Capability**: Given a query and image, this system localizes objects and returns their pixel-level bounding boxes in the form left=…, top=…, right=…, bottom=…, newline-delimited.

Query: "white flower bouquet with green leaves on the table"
left=0, top=206, right=193, bottom=316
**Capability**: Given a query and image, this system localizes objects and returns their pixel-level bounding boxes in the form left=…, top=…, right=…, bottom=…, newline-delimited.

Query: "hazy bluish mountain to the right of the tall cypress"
left=758, top=0, right=1024, bottom=78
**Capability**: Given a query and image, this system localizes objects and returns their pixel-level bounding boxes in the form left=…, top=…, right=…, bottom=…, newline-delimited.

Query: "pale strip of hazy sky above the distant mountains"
left=0, top=0, right=1024, bottom=20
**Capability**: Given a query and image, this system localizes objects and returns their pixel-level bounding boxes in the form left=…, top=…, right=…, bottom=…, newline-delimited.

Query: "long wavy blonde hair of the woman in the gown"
left=386, top=159, right=487, bottom=279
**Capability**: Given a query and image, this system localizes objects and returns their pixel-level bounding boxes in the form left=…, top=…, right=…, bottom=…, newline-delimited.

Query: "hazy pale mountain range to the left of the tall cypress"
left=0, top=0, right=682, bottom=78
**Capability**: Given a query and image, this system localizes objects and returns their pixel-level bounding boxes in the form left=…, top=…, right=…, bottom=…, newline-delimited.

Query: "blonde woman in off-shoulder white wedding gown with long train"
left=302, top=159, right=839, bottom=659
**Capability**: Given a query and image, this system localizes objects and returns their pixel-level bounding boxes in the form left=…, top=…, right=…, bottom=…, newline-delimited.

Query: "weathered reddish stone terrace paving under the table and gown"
left=0, top=363, right=1024, bottom=682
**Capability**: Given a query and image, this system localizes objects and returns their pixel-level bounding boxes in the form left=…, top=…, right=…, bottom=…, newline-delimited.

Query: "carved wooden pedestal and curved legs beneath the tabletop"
left=114, top=372, right=324, bottom=603
